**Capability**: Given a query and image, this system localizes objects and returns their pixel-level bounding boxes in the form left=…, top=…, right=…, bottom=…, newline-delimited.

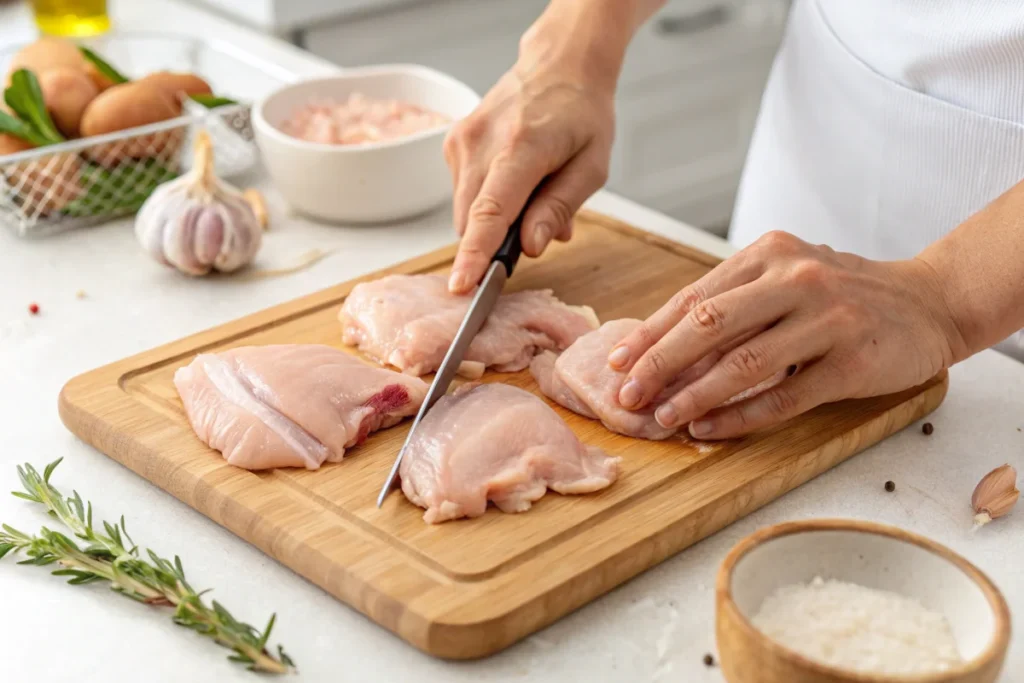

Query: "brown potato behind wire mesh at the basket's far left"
left=0, top=134, right=83, bottom=216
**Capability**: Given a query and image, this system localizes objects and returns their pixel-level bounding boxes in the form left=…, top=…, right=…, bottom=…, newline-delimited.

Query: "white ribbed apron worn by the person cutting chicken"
left=729, top=0, right=1024, bottom=359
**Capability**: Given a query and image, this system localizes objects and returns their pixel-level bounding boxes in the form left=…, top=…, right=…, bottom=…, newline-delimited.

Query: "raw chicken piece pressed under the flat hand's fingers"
left=529, top=318, right=786, bottom=440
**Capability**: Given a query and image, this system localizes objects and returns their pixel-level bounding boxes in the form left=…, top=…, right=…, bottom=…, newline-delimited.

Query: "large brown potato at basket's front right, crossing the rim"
left=81, top=81, right=185, bottom=167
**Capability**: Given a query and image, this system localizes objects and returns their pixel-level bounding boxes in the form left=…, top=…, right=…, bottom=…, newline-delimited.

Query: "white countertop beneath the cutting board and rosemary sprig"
left=0, top=0, right=1024, bottom=683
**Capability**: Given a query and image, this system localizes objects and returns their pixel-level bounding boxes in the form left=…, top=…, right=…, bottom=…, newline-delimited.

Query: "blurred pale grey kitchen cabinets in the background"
left=303, top=0, right=790, bottom=233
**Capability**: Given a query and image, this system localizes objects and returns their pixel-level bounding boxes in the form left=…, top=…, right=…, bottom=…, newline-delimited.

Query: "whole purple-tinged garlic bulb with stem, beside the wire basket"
left=135, top=131, right=263, bottom=275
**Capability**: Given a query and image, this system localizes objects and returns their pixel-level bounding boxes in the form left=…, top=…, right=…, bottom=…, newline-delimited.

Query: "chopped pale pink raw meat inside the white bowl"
left=281, top=92, right=450, bottom=144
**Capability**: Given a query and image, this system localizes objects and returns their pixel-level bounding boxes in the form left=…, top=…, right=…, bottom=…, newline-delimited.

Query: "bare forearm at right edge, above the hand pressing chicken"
left=919, top=176, right=1024, bottom=360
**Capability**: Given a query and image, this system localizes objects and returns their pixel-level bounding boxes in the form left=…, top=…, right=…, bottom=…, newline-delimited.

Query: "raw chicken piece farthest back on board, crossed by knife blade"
left=338, top=274, right=598, bottom=379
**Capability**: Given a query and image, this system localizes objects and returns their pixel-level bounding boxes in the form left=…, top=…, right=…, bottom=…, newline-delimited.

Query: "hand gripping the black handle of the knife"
left=444, top=10, right=625, bottom=293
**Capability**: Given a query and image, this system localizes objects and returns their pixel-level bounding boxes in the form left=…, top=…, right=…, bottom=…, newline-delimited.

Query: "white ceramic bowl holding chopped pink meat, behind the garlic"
left=252, top=65, right=480, bottom=223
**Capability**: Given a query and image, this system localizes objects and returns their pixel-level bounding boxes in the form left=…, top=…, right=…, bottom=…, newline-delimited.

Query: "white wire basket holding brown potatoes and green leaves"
left=0, top=34, right=287, bottom=237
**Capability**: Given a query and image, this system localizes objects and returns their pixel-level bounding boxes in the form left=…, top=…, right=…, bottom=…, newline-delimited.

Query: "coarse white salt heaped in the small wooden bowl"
left=752, top=577, right=963, bottom=674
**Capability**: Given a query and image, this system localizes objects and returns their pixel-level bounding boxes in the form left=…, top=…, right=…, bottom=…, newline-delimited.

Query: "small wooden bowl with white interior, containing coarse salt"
left=715, top=519, right=1010, bottom=683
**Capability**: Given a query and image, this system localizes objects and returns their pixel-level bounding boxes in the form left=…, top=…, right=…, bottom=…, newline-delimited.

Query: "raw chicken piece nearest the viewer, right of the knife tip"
left=399, top=383, right=618, bottom=524
